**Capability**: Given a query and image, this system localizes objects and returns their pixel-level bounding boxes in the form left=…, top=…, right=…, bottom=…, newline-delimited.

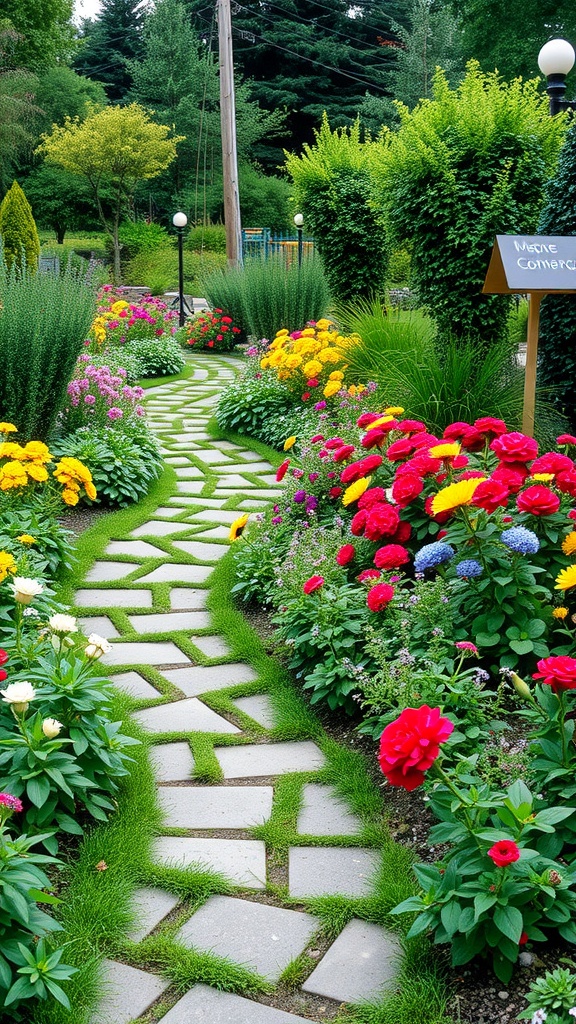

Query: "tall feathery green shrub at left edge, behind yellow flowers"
left=0, top=256, right=95, bottom=439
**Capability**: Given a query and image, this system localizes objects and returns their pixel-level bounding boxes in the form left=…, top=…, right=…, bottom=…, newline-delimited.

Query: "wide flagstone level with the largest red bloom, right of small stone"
left=214, top=739, right=326, bottom=778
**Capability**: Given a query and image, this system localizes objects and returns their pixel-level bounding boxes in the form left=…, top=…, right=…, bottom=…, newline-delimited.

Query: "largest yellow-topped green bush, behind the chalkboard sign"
left=372, top=61, right=566, bottom=347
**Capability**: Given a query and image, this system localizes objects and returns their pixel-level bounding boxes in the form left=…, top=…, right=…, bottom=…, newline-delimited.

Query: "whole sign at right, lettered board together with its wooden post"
left=482, top=234, right=576, bottom=436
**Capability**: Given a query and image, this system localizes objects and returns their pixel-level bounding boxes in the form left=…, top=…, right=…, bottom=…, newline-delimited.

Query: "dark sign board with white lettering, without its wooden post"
left=483, top=234, right=576, bottom=295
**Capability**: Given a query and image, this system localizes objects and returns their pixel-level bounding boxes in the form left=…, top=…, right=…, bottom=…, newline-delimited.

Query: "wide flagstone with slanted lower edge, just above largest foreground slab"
left=153, top=836, right=266, bottom=889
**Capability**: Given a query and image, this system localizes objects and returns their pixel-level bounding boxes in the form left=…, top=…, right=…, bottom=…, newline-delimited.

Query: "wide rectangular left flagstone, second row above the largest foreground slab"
left=158, top=785, right=274, bottom=828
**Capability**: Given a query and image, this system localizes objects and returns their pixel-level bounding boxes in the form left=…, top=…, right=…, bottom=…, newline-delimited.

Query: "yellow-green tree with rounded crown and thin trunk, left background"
left=38, top=103, right=182, bottom=284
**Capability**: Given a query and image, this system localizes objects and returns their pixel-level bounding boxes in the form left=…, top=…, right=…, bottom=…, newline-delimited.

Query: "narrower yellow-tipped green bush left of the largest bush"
left=286, top=115, right=387, bottom=300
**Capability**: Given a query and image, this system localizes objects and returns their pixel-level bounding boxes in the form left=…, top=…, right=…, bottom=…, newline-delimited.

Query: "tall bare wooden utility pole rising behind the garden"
left=217, top=0, right=242, bottom=267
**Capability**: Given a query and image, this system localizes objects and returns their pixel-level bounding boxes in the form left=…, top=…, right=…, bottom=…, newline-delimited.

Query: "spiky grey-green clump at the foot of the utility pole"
left=202, top=258, right=330, bottom=340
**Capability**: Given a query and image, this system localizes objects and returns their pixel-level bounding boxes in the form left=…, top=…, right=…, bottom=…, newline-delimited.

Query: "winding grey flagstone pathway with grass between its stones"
left=76, top=355, right=398, bottom=1024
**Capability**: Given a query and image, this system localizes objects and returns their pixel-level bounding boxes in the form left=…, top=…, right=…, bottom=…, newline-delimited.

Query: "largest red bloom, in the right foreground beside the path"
left=378, top=705, right=454, bottom=793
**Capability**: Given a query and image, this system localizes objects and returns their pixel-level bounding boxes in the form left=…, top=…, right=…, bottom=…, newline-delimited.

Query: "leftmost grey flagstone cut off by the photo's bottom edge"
left=89, top=959, right=170, bottom=1024
